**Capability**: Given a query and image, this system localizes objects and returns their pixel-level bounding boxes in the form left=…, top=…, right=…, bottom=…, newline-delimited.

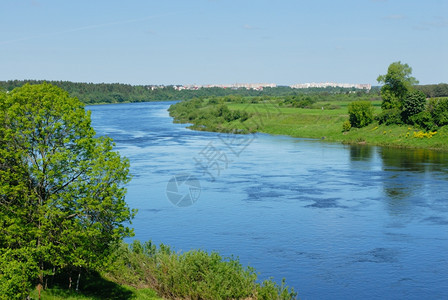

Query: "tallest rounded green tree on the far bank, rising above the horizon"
left=377, top=61, right=418, bottom=110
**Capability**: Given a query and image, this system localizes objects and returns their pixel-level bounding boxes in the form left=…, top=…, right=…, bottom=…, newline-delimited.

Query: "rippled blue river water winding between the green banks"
left=87, top=102, right=448, bottom=299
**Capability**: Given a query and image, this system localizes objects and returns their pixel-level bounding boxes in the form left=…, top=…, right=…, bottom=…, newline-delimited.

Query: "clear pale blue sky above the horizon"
left=0, top=0, right=448, bottom=85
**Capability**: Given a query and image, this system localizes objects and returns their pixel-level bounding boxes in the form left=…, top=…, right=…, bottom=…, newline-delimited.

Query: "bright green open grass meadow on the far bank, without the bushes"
left=224, top=101, right=448, bottom=151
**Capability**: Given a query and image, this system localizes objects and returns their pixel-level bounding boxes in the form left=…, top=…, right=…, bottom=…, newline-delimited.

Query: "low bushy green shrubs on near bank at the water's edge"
left=105, top=241, right=297, bottom=300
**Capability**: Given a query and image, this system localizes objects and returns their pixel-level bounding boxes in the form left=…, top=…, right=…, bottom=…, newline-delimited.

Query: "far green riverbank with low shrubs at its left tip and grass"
left=170, top=100, right=448, bottom=151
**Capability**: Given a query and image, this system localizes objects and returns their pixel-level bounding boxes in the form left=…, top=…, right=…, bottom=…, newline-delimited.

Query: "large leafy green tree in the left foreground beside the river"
left=0, top=83, right=135, bottom=294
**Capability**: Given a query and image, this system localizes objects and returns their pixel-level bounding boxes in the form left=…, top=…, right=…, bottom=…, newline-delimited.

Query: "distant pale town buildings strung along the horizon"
left=150, top=82, right=372, bottom=91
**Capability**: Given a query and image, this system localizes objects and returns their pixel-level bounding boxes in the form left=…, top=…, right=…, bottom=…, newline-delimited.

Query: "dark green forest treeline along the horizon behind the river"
left=0, top=80, right=379, bottom=104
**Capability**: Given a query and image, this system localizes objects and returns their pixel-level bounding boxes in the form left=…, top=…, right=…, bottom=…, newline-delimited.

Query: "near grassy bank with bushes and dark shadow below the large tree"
left=26, top=240, right=297, bottom=300
